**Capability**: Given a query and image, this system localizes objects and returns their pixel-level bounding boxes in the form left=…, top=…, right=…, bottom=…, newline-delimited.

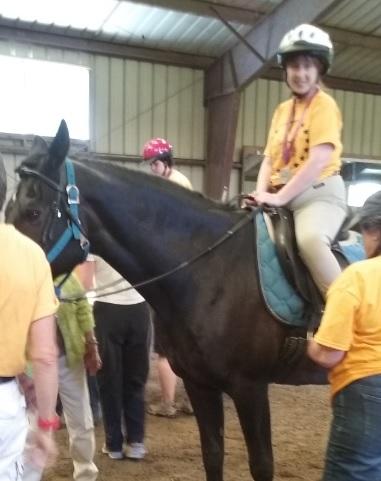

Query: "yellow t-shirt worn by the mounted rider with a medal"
left=264, top=90, right=343, bottom=186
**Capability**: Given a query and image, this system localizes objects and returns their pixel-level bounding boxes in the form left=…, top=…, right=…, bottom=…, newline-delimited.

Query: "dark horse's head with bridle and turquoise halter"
left=5, top=120, right=86, bottom=275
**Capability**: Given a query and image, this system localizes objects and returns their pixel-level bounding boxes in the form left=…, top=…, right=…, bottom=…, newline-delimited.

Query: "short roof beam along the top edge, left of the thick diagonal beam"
left=123, top=0, right=264, bottom=25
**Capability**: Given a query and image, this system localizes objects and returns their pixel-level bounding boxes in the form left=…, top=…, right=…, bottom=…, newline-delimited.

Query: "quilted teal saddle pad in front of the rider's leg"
left=254, top=212, right=308, bottom=327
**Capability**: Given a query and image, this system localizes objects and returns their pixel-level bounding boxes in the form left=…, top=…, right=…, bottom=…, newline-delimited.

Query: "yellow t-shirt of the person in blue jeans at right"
left=315, top=256, right=381, bottom=395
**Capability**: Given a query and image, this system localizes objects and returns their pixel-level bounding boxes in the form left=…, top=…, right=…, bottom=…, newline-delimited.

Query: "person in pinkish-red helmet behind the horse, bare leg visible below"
left=142, top=138, right=193, bottom=417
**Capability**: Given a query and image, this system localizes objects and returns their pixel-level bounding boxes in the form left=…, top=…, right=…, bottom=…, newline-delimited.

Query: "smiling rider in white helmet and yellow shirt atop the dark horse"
left=248, top=24, right=346, bottom=297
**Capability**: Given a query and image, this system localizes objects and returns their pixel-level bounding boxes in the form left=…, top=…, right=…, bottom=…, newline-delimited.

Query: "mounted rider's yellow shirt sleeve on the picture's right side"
left=309, top=95, right=342, bottom=149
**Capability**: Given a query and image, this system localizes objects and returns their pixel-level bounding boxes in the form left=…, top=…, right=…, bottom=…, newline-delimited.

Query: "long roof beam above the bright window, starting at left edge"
left=0, top=24, right=214, bottom=69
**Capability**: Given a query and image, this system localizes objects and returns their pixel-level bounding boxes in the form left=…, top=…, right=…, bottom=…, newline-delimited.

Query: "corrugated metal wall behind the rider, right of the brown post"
left=235, top=80, right=381, bottom=160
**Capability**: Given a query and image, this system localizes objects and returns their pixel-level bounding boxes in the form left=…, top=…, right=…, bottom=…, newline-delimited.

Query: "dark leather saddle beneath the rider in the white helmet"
left=266, top=207, right=355, bottom=329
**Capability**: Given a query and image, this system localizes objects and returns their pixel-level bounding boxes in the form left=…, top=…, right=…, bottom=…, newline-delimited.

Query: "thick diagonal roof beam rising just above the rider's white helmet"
left=205, top=0, right=343, bottom=100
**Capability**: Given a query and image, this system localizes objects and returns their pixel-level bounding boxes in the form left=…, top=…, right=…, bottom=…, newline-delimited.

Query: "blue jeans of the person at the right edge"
left=322, top=375, right=381, bottom=481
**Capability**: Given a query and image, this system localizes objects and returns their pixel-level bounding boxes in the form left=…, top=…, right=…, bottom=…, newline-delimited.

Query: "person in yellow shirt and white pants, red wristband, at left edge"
left=0, top=158, right=58, bottom=480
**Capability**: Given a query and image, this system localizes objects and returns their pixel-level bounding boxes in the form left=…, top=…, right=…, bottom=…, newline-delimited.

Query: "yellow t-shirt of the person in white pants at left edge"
left=0, top=224, right=58, bottom=376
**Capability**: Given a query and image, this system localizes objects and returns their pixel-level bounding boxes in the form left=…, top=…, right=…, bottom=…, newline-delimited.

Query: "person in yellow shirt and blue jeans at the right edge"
left=307, top=192, right=381, bottom=481
